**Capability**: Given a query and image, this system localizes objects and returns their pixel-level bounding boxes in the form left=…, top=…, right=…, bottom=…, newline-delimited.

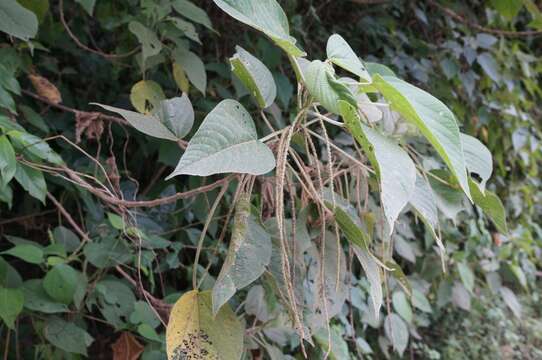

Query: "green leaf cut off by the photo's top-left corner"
left=0, top=0, right=38, bottom=41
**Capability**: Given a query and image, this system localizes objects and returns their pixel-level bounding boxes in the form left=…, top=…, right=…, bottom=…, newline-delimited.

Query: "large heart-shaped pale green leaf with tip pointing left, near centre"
left=166, top=100, right=275, bottom=179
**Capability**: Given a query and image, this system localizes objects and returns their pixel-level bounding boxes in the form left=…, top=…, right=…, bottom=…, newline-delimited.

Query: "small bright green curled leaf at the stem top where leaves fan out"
left=303, top=60, right=356, bottom=114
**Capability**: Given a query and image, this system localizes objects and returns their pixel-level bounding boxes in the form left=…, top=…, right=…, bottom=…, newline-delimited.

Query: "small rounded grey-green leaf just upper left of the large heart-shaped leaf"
left=156, top=94, right=194, bottom=139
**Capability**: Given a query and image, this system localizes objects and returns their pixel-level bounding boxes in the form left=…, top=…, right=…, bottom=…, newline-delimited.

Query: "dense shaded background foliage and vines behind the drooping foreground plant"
left=0, top=0, right=542, bottom=359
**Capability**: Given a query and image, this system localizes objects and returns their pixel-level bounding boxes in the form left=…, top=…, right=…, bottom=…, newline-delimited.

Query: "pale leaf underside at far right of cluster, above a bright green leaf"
left=461, top=134, right=493, bottom=192
